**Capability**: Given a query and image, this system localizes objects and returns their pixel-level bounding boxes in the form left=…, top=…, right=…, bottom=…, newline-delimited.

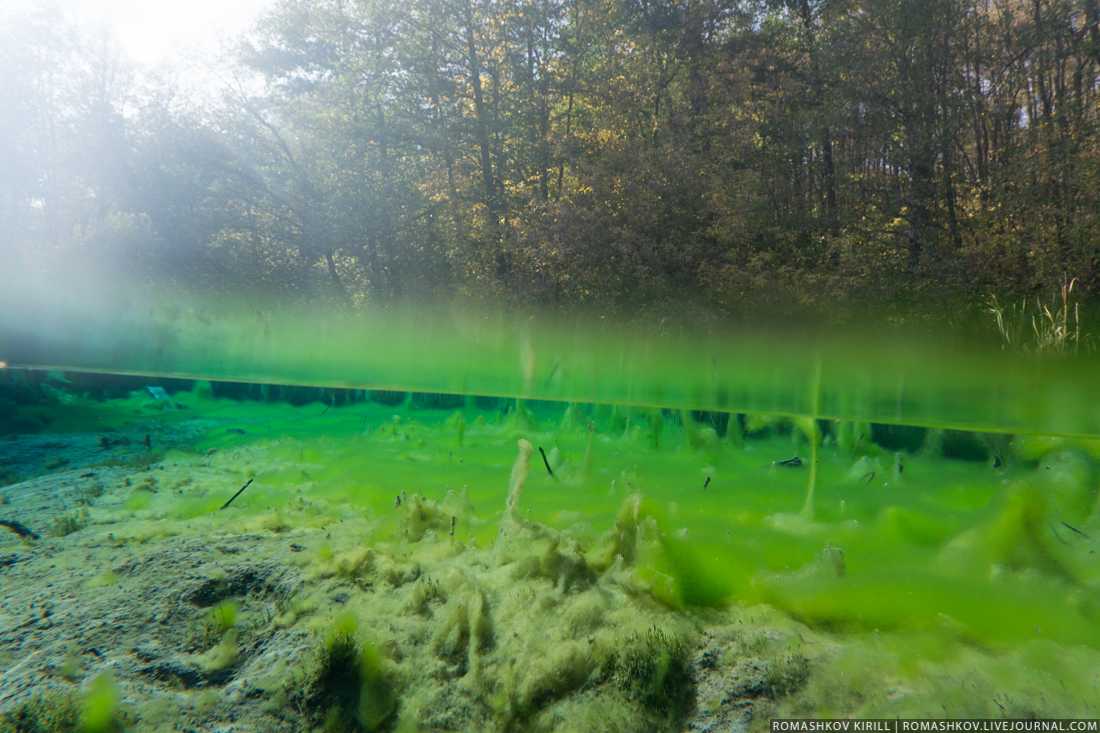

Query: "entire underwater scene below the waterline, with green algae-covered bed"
left=0, top=356, right=1100, bottom=732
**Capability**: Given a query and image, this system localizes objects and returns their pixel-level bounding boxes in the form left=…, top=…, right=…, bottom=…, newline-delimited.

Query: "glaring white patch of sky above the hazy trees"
left=3, top=0, right=274, bottom=66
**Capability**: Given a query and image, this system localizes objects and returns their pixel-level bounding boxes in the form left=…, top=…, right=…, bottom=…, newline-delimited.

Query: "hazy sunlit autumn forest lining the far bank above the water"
left=0, top=0, right=1100, bottom=318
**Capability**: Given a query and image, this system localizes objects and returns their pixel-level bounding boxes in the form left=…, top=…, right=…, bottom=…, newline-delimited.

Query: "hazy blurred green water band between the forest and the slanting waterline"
left=0, top=272, right=1100, bottom=437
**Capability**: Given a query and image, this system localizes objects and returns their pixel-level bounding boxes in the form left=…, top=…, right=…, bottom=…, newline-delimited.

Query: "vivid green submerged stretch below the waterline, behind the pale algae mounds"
left=8, top=376, right=1100, bottom=646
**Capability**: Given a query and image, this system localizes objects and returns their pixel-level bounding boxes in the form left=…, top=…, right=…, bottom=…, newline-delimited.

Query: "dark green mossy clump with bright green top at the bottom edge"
left=287, top=614, right=397, bottom=733
